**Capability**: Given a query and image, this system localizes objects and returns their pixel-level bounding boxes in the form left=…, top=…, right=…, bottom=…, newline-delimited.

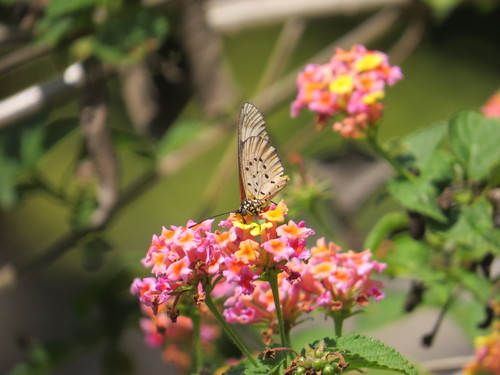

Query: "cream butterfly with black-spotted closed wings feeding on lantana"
left=236, top=102, right=290, bottom=217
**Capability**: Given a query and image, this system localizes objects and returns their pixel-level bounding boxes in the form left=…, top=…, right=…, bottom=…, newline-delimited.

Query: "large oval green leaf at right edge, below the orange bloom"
left=449, top=111, right=500, bottom=180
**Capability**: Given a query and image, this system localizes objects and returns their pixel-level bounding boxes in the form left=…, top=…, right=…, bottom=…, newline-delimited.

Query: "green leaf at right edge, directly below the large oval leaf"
left=445, top=197, right=500, bottom=260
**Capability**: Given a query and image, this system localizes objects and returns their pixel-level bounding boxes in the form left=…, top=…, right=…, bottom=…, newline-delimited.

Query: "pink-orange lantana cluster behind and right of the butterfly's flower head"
left=224, top=238, right=386, bottom=327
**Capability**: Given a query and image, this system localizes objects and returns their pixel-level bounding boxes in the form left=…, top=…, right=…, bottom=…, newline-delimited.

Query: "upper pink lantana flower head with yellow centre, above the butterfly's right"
left=291, top=45, right=403, bottom=138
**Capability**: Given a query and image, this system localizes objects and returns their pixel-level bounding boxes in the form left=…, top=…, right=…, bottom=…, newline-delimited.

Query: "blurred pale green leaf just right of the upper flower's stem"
left=402, top=122, right=446, bottom=171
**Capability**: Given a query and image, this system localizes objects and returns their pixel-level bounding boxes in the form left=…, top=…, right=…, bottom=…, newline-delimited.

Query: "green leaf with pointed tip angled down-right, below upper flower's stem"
left=388, top=179, right=447, bottom=223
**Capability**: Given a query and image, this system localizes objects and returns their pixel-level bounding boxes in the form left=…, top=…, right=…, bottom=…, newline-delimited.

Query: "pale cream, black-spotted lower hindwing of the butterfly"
left=240, top=137, right=290, bottom=204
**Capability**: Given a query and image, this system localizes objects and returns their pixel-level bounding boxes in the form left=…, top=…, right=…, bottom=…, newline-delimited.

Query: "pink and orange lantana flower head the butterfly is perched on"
left=131, top=201, right=314, bottom=312
